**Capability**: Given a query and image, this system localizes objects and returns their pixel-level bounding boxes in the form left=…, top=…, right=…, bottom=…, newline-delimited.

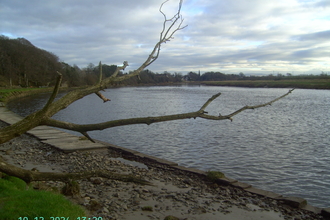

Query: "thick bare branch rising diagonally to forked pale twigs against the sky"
left=0, top=0, right=186, bottom=144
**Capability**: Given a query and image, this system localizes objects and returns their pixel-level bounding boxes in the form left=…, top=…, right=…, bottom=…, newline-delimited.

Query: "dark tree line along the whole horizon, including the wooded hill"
left=0, top=35, right=330, bottom=87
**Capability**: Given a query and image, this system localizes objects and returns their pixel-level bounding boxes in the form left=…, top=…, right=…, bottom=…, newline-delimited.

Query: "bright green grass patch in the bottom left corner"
left=0, top=175, right=86, bottom=220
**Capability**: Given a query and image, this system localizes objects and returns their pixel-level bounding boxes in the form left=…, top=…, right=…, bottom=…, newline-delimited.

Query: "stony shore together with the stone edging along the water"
left=0, top=106, right=329, bottom=220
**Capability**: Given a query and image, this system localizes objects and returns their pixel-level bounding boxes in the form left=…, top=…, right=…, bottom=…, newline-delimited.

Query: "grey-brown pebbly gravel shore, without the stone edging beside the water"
left=0, top=121, right=325, bottom=220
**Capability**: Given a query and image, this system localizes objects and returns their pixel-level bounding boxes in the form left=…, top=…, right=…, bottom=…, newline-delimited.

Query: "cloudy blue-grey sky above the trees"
left=0, top=0, right=330, bottom=74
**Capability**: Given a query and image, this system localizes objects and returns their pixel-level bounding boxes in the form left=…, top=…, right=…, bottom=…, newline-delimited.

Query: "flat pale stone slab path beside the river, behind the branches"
left=0, top=103, right=109, bottom=152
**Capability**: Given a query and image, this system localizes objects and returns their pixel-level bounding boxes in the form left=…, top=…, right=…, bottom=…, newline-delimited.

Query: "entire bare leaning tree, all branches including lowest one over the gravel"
left=0, top=0, right=292, bottom=184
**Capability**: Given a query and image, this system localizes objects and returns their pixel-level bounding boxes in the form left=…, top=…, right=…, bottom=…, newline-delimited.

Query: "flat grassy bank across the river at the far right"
left=201, top=79, right=330, bottom=89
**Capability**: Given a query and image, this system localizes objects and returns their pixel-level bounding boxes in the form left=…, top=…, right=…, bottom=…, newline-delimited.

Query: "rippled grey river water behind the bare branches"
left=9, top=86, right=330, bottom=207
